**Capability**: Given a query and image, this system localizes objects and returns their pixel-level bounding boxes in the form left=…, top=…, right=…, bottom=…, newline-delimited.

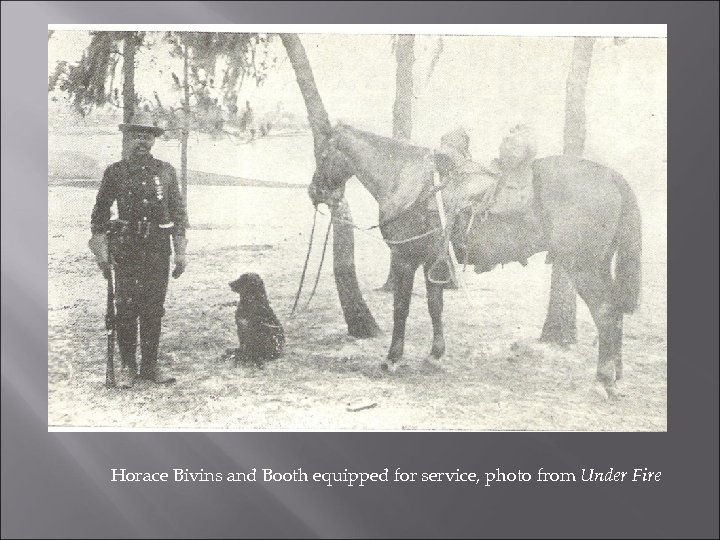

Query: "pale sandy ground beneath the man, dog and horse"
left=48, top=135, right=667, bottom=431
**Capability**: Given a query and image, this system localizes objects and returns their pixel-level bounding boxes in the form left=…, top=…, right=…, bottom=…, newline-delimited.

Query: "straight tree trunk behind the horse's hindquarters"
left=540, top=37, right=595, bottom=345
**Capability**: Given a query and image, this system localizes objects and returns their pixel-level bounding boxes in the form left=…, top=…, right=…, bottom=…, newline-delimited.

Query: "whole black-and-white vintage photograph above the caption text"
left=48, top=26, right=668, bottom=432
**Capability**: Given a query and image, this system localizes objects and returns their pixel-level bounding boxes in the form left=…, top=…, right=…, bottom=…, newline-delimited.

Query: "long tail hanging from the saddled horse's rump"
left=613, top=177, right=642, bottom=313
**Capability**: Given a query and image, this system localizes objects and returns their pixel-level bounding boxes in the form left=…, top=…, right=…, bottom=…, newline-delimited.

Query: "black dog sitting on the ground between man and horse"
left=230, top=273, right=285, bottom=364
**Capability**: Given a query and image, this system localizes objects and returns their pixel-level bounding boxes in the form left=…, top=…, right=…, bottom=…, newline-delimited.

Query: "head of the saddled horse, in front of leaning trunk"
left=308, top=130, right=354, bottom=206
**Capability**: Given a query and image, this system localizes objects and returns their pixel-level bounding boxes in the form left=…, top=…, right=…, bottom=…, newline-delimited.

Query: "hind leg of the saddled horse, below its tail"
left=572, top=263, right=623, bottom=397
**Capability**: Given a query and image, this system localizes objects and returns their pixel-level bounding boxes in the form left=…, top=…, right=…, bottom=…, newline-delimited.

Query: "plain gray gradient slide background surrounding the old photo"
left=1, top=2, right=718, bottom=537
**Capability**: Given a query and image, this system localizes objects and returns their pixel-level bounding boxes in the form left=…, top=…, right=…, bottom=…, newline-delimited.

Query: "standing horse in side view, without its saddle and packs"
left=308, top=124, right=642, bottom=397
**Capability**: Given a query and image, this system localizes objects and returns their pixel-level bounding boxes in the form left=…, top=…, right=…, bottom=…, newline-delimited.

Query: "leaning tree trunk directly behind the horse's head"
left=280, top=34, right=379, bottom=337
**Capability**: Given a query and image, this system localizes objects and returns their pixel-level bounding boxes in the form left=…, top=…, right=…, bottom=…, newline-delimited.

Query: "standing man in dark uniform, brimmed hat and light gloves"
left=89, top=112, right=187, bottom=386
